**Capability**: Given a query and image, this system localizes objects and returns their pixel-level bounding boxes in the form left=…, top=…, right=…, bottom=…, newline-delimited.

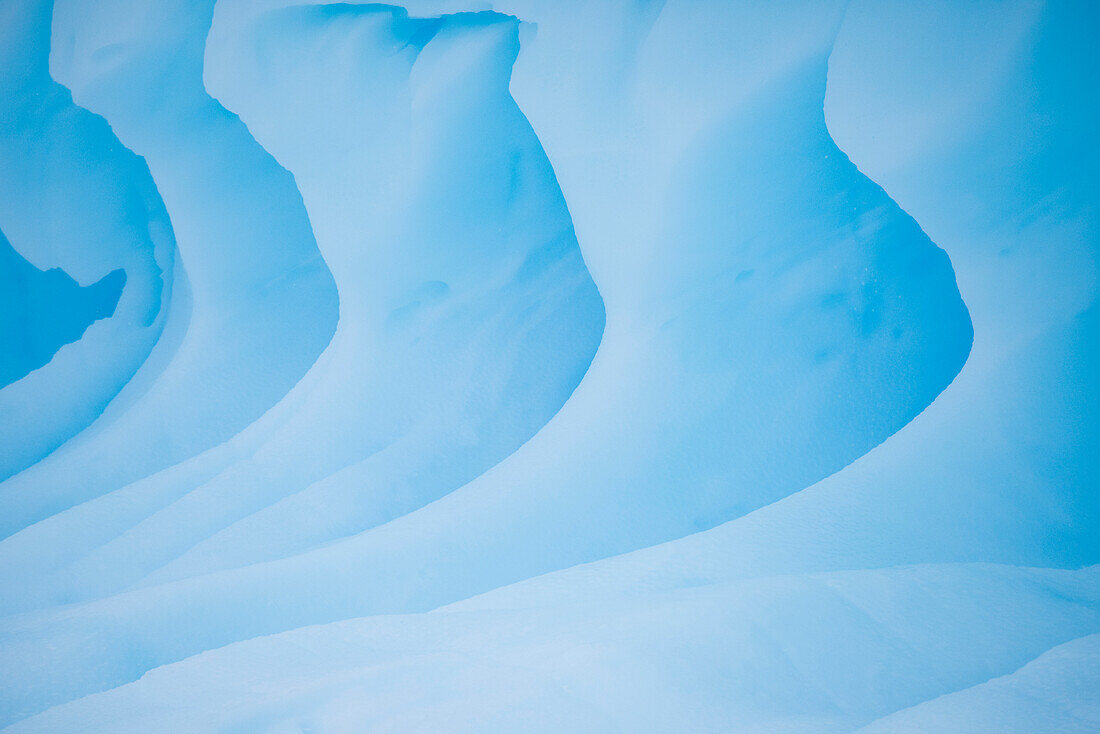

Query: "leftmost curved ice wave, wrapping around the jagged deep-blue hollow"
left=0, top=0, right=176, bottom=481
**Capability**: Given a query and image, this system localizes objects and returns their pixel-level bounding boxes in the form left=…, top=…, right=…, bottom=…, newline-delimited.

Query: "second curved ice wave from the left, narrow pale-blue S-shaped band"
left=4, top=2, right=337, bottom=533
